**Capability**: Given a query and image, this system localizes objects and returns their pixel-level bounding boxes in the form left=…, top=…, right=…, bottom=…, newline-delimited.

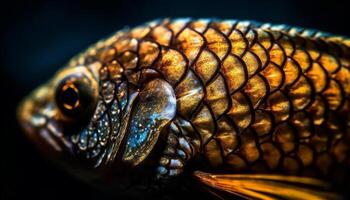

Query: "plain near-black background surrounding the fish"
left=0, top=0, right=350, bottom=200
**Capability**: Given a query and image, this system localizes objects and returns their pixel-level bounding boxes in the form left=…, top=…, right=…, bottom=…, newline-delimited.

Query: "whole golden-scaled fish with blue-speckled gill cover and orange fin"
left=18, top=18, right=350, bottom=199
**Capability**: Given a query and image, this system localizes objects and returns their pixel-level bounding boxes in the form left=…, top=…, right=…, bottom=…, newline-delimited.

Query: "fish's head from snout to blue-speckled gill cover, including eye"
left=17, top=49, right=176, bottom=189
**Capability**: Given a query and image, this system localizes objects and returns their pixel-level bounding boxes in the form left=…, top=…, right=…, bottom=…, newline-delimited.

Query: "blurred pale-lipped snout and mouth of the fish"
left=17, top=85, right=72, bottom=156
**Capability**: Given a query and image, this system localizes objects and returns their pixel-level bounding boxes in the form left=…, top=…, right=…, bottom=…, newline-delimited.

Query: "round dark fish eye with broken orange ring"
left=55, top=72, right=96, bottom=119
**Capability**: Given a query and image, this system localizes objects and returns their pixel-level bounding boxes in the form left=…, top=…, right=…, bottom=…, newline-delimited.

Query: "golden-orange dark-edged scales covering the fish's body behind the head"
left=36, top=19, right=350, bottom=183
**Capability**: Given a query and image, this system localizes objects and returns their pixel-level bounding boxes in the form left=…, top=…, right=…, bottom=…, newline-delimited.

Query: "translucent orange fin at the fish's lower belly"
left=194, top=171, right=342, bottom=200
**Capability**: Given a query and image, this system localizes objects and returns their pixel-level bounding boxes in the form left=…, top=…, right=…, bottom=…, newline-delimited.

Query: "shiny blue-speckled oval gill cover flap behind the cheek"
left=123, top=79, right=176, bottom=165
